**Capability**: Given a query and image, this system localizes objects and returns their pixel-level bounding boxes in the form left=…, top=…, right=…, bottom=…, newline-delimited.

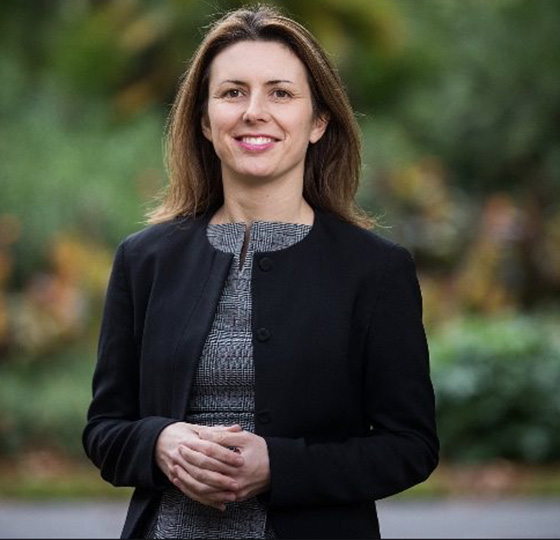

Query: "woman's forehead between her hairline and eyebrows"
left=210, top=41, right=306, bottom=84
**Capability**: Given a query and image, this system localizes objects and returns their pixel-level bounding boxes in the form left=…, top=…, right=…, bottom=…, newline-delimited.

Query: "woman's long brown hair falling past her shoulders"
left=147, top=5, right=373, bottom=228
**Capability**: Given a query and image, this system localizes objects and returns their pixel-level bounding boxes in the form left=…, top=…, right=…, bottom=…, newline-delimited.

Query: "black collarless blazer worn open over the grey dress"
left=83, top=209, right=438, bottom=538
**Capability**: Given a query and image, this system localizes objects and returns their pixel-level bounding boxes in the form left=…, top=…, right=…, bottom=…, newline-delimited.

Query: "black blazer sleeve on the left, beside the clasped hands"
left=82, top=241, right=176, bottom=489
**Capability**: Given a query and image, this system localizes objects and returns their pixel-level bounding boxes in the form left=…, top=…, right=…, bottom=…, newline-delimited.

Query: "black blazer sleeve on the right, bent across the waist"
left=265, top=245, right=439, bottom=506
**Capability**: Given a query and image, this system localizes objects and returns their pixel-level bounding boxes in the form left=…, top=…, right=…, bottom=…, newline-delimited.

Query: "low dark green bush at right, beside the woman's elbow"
left=431, top=315, right=560, bottom=463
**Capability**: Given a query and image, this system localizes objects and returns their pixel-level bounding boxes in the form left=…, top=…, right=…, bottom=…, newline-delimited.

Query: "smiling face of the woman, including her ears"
left=202, top=41, right=327, bottom=186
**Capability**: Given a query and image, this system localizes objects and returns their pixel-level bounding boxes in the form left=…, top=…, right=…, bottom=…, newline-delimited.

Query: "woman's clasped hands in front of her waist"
left=155, top=422, right=270, bottom=511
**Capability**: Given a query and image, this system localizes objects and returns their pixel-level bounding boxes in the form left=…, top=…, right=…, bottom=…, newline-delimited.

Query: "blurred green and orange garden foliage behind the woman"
left=0, top=0, right=560, bottom=536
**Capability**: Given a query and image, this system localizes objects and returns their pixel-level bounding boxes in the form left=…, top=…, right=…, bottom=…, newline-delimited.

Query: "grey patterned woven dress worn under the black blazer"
left=146, top=221, right=311, bottom=539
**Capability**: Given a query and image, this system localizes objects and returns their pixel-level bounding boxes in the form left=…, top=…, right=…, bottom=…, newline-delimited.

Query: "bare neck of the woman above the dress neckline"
left=211, top=173, right=313, bottom=225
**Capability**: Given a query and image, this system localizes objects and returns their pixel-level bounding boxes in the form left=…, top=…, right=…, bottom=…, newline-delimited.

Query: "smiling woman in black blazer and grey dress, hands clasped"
left=84, top=7, right=438, bottom=538
